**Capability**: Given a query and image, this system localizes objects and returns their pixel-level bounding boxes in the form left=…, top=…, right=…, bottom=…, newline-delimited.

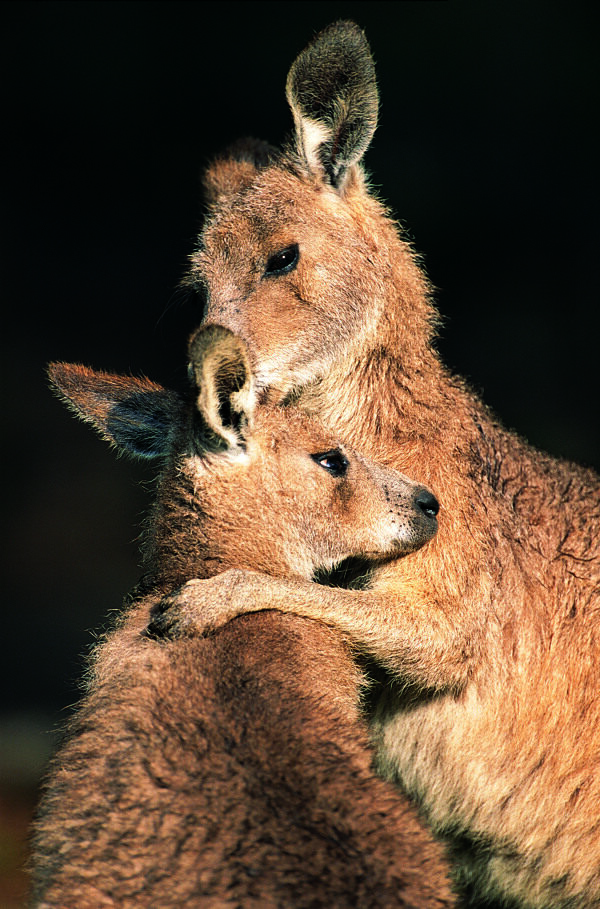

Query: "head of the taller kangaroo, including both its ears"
left=187, top=22, right=430, bottom=396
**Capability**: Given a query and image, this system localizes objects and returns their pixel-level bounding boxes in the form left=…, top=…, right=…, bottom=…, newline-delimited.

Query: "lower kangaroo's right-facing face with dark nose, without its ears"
left=180, top=407, right=437, bottom=579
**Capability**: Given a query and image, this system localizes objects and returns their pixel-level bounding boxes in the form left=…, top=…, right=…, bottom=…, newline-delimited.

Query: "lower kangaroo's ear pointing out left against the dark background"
left=48, top=363, right=183, bottom=458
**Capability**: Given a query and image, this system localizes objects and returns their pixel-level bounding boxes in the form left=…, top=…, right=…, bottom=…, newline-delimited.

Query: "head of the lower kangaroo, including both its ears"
left=50, top=326, right=437, bottom=586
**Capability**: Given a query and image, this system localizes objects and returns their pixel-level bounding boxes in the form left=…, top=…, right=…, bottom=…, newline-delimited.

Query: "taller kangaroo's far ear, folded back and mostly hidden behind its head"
left=202, top=138, right=277, bottom=205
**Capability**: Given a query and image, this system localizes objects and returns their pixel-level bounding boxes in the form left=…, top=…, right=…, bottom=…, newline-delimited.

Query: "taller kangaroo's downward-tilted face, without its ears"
left=190, top=165, right=386, bottom=394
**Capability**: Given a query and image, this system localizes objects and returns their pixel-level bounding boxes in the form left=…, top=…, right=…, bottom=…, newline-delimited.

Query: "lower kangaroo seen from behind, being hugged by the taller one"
left=32, top=326, right=453, bottom=909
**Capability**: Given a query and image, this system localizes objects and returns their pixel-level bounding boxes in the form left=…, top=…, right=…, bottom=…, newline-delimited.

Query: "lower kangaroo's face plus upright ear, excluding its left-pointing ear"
left=175, top=326, right=437, bottom=578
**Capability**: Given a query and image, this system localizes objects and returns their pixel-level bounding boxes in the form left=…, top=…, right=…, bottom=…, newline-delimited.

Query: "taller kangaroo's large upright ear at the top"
left=286, top=22, right=379, bottom=189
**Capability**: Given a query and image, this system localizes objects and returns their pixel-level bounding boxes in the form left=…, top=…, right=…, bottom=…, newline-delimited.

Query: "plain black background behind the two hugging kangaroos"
left=0, top=2, right=600, bottom=896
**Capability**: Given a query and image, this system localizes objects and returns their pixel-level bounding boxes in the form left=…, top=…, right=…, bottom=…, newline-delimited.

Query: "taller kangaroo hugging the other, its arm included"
left=158, top=22, right=600, bottom=909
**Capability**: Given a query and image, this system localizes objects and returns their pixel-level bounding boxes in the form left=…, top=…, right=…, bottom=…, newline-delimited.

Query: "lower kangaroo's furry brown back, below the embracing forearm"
left=34, top=604, right=452, bottom=909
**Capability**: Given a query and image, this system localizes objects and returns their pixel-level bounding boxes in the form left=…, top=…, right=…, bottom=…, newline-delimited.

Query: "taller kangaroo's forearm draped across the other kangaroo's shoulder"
left=160, top=569, right=473, bottom=690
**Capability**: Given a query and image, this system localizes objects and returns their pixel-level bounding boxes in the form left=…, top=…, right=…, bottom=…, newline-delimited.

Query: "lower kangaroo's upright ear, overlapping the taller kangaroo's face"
left=189, top=325, right=256, bottom=451
